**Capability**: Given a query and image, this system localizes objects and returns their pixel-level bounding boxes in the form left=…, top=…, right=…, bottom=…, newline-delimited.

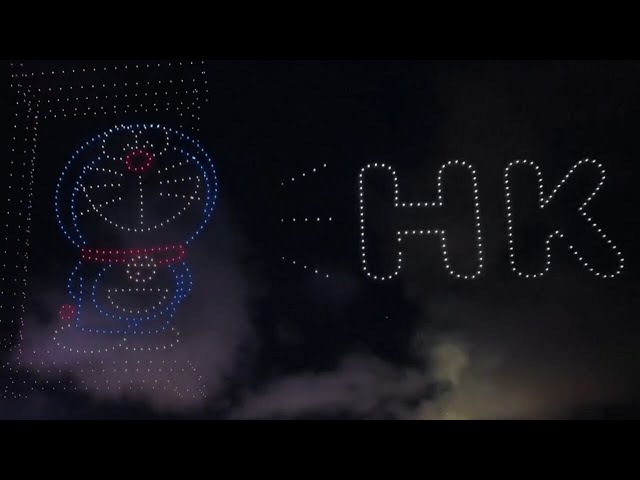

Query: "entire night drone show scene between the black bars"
left=0, top=60, right=640, bottom=420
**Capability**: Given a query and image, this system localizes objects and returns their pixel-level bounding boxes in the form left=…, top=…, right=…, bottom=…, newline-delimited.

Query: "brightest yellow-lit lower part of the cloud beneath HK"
left=413, top=334, right=625, bottom=420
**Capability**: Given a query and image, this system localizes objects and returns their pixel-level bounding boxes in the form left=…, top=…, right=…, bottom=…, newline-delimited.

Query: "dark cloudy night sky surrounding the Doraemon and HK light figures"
left=0, top=60, right=640, bottom=419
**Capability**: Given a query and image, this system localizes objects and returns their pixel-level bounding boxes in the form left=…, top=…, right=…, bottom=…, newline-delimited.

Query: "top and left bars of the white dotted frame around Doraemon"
left=0, top=61, right=208, bottom=353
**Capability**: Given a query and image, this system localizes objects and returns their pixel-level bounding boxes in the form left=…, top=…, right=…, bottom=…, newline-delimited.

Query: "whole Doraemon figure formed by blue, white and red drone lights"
left=50, top=125, right=218, bottom=402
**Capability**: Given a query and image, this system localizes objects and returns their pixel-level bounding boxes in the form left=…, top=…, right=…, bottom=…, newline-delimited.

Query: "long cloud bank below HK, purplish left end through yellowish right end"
left=231, top=275, right=640, bottom=420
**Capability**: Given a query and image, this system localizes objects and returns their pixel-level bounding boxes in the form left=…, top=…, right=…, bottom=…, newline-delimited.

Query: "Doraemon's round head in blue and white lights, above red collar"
left=57, top=125, right=217, bottom=246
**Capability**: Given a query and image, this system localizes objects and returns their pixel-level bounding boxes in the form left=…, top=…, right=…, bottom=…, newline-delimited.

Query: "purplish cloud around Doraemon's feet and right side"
left=7, top=211, right=256, bottom=411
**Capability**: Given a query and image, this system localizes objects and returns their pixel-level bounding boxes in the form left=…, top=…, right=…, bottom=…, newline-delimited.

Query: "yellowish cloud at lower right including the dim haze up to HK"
left=404, top=281, right=640, bottom=419
